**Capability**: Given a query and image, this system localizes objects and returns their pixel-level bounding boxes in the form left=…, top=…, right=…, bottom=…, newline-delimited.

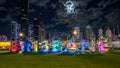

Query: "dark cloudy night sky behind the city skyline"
left=0, top=0, right=120, bottom=35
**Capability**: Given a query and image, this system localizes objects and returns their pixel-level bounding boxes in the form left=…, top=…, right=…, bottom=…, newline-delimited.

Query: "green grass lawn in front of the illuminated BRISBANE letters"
left=0, top=51, right=120, bottom=68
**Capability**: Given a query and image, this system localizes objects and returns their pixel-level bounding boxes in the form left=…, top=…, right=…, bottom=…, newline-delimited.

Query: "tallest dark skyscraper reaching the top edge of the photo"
left=18, top=0, right=29, bottom=38
